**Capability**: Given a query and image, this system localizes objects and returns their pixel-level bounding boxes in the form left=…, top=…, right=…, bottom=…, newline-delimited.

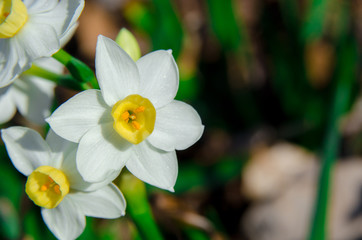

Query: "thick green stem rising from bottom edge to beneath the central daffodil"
left=118, top=172, right=163, bottom=240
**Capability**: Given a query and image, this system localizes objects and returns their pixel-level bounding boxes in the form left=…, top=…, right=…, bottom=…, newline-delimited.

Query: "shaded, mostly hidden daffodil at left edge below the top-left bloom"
left=0, top=58, right=63, bottom=125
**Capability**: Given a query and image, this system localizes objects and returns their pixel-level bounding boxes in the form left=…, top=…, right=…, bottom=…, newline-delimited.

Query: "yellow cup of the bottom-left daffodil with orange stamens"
left=25, top=166, right=69, bottom=208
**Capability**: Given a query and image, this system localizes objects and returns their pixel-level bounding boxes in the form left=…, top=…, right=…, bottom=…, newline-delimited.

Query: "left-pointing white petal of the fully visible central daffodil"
left=46, top=89, right=113, bottom=142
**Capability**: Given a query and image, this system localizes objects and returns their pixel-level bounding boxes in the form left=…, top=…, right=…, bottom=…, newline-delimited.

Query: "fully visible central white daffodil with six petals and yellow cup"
left=46, top=36, right=204, bottom=191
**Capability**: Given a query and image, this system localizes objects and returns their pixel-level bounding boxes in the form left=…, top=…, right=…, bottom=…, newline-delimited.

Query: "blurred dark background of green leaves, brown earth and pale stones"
left=0, top=0, right=362, bottom=240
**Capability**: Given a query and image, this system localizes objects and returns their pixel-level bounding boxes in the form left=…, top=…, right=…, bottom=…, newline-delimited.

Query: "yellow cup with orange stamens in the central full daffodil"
left=112, top=94, right=156, bottom=144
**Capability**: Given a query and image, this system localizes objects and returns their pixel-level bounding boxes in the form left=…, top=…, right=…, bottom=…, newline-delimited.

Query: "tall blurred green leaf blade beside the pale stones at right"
left=309, top=36, right=357, bottom=240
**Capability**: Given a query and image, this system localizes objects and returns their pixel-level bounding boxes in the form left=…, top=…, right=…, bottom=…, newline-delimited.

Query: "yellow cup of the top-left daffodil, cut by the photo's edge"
left=0, top=0, right=28, bottom=38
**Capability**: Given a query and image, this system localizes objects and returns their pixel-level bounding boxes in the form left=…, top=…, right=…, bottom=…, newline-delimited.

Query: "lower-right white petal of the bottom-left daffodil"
left=69, top=183, right=126, bottom=218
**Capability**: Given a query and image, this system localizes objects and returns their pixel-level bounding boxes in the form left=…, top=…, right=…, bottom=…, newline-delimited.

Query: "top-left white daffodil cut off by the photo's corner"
left=0, top=0, right=84, bottom=88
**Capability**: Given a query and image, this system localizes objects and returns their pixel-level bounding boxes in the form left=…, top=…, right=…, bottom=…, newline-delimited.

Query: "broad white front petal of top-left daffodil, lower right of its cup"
left=15, top=19, right=60, bottom=62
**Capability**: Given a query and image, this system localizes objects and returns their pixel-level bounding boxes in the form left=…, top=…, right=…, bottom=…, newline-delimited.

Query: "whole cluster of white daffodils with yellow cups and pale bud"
left=0, top=0, right=204, bottom=239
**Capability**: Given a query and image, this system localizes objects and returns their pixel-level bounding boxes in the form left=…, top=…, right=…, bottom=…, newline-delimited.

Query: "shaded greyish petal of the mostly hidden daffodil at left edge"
left=12, top=75, right=55, bottom=125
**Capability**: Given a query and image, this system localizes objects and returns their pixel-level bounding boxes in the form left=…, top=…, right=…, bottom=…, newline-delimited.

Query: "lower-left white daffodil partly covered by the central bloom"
left=1, top=127, right=126, bottom=239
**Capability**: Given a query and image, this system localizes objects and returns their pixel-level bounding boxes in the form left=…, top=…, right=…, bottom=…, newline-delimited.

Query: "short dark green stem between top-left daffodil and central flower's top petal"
left=53, top=49, right=99, bottom=88
